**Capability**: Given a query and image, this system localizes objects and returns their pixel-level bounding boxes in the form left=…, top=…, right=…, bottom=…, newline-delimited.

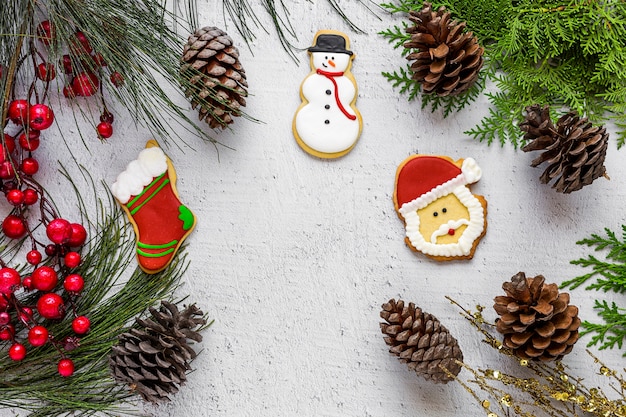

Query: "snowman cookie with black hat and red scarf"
left=292, top=30, right=363, bottom=158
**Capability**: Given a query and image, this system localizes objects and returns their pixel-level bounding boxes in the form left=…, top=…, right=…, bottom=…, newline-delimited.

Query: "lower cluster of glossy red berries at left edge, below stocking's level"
left=0, top=218, right=91, bottom=377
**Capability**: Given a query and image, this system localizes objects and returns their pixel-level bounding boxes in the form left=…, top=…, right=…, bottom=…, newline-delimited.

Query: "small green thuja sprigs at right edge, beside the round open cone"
left=562, top=225, right=626, bottom=356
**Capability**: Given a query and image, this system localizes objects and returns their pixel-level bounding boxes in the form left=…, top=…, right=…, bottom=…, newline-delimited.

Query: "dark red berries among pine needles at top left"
left=35, top=20, right=124, bottom=139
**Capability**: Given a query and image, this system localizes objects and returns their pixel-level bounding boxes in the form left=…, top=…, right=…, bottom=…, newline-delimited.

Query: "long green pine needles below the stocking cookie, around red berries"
left=0, top=179, right=197, bottom=417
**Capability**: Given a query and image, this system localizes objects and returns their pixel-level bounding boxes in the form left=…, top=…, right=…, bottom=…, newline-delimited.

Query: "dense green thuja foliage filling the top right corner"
left=381, top=0, right=626, bottom=147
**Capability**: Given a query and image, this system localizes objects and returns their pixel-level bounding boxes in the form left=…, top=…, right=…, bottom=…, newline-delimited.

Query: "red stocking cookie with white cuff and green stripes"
left=111, top=140, right=196, bottom=274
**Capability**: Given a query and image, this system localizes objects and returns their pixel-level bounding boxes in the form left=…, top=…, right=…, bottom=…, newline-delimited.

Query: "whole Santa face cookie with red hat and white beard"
left=393, top=155, right=487, bottom=261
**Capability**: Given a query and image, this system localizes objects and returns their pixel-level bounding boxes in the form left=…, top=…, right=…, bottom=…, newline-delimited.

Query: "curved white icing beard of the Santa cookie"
left=402, top=186, right=485, bottom=258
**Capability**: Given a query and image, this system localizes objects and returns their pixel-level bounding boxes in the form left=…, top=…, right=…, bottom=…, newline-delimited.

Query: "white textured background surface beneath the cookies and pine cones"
left=3, top=0, right=626, bottom=417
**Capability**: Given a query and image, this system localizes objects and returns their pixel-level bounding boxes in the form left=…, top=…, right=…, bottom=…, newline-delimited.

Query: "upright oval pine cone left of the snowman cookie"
left=181, top=27, right=248, bottom=129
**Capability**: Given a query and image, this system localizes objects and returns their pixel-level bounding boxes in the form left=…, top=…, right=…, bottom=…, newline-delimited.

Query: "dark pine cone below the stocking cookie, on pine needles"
left=109, top=301, right=206, bottom=404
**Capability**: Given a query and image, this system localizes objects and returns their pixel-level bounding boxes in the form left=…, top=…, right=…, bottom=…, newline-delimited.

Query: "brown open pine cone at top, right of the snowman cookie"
left=404, top=2, right=484, bottom=96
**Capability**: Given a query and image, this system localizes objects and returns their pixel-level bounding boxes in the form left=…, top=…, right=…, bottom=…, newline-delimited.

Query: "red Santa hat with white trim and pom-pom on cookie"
left=394, top=155, right=482, bottom=214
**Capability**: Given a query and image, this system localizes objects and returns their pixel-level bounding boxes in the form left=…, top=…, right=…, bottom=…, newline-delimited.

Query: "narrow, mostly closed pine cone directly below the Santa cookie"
left=380, top=299, right=463, bottom=384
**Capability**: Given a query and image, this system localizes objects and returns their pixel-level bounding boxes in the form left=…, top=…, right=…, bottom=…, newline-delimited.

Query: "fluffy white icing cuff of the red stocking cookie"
left=111, top=146, right=167, bottom=204
